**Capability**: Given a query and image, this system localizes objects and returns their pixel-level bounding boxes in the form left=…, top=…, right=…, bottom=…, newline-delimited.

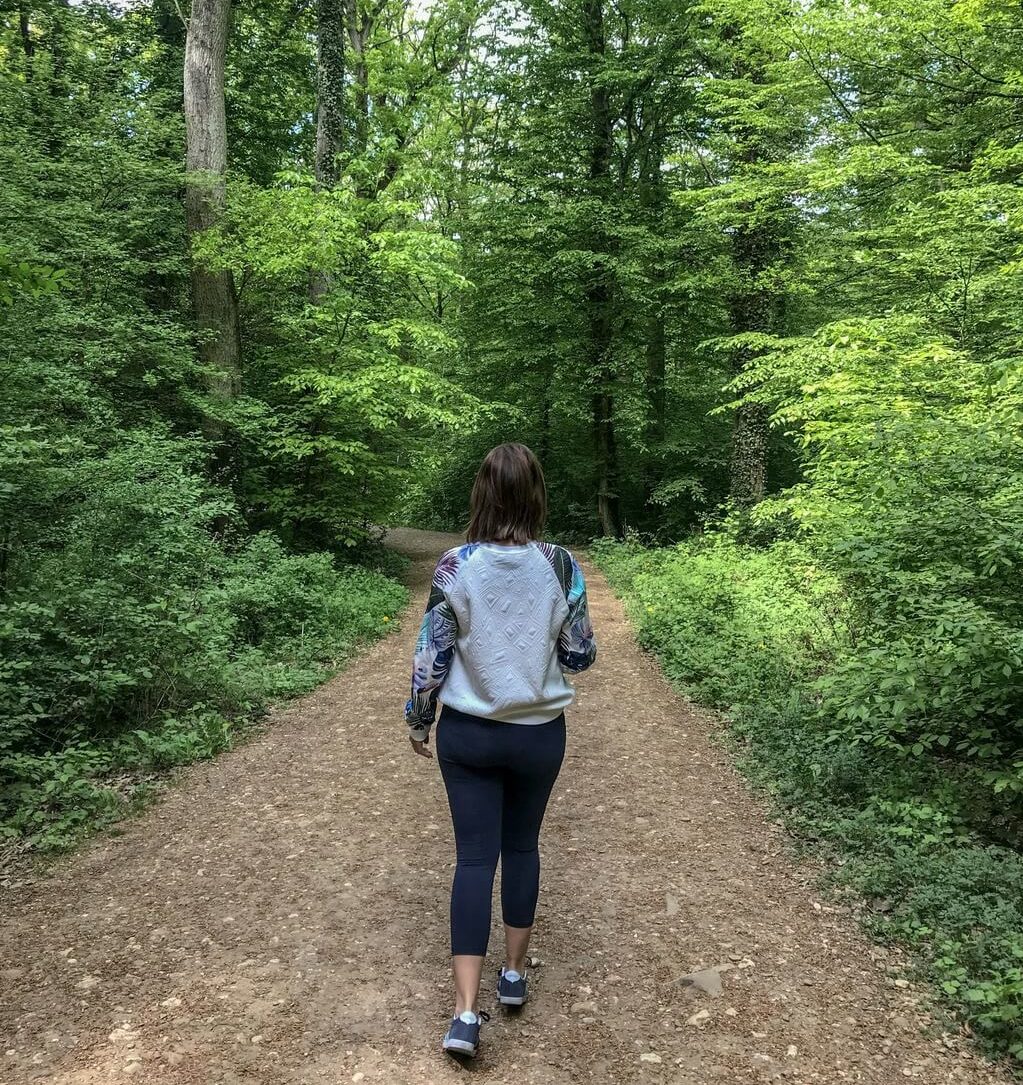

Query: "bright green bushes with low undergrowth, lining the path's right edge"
left=594, top=316, right=1023, bottom=1059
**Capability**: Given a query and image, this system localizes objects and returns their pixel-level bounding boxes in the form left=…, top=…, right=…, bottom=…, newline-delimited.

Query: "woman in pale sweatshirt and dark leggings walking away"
left=405, top=444, right=597, bottom=1055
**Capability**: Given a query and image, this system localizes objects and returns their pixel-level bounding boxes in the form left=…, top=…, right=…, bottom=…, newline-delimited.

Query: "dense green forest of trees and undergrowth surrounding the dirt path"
left=0, top=0, right=1023, bottom=1059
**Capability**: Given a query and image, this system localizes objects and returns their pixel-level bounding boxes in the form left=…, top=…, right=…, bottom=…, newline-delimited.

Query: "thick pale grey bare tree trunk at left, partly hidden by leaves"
left=184, top=0, right=242, bottom=455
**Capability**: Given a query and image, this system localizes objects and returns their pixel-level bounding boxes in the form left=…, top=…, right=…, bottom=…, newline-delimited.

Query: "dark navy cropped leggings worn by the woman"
left=437, top=705, right=565, bottom=957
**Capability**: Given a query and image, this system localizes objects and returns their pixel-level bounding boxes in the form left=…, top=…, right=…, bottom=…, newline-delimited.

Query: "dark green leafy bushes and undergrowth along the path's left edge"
left=0, top=434, right=406, bottom=848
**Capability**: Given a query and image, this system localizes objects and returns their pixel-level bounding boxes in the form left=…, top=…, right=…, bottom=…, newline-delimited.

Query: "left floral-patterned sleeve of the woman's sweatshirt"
left=405, top=546, right=472, bottom=742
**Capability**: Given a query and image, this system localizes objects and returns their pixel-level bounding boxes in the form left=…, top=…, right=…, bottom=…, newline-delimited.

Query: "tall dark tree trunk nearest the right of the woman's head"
left=583, top=0, right=622, bottom=537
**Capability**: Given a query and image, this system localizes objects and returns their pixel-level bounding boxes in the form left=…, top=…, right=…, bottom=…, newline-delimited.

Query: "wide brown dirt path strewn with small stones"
left=0, top=531, right=1008, bottom=1085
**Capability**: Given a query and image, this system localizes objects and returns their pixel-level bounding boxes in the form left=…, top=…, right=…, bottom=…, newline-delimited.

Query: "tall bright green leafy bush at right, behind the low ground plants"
left=749, top=318, right=1023, bottom=802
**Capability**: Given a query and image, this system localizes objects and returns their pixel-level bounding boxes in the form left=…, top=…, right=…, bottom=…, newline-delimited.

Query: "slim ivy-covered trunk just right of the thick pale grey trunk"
left=309, top=0, right=345, bottom=302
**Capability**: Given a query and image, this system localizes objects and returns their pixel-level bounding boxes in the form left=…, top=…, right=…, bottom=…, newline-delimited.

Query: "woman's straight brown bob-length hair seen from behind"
left=465, top=444, right=547, bottom=544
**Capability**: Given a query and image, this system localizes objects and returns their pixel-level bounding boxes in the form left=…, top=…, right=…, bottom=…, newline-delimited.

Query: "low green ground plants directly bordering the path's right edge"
left=590, top=522, right=1023, bottom=1058
